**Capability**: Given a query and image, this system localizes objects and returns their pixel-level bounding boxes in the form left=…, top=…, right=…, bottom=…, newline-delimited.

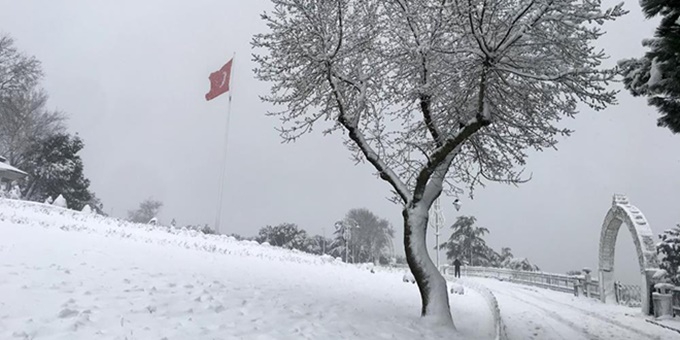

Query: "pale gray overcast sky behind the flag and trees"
left=0, top=0, right=680, bottom=281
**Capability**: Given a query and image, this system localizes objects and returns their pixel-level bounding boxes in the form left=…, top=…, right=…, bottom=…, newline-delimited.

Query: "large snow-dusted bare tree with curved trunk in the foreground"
left=253, top=0, right=624, bottom=326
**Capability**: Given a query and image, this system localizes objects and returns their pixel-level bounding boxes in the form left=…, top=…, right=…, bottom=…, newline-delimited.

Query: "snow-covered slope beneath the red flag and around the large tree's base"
left=0, top=199, right=493, bottom=340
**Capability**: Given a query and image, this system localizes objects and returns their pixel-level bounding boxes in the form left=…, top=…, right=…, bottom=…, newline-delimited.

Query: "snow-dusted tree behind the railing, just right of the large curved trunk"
left=439, top=216, right=493, bottom=266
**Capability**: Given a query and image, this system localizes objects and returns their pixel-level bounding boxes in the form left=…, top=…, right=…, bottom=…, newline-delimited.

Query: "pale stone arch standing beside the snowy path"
left=599, top=195, right=659, bottom=314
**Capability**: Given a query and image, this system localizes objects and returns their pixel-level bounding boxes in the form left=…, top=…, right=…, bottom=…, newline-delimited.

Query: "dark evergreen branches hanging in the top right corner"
left=619, top=0, right=680, bottom=133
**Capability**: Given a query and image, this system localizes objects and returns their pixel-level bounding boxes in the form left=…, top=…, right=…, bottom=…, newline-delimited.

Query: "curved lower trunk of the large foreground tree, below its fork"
left=402, top=202, right=455, bottom=327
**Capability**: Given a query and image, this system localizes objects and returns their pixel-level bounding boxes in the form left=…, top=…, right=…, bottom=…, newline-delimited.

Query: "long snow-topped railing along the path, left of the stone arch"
left=442, top=266, right=600, bottom=298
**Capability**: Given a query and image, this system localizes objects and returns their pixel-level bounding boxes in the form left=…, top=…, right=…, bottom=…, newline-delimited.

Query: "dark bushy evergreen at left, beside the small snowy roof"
left=23, top=133, right=101, bottom=210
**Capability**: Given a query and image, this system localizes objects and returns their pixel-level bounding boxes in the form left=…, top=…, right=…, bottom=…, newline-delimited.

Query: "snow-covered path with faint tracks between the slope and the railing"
left=472, top=278, right=680, bottom=340
